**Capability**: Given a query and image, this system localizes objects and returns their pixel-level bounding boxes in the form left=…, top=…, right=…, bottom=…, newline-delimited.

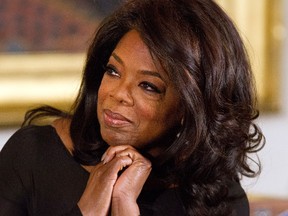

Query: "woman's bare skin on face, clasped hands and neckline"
left=53, top=30, right=181, bottom=216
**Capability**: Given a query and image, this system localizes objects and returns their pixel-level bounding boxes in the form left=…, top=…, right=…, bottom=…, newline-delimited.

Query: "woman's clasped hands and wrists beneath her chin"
left=78, top=145, right=152, bottom=216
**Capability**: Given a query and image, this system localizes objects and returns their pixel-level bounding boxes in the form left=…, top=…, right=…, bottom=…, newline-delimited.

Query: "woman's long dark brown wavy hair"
left=23, top=0, right=264, bottom=216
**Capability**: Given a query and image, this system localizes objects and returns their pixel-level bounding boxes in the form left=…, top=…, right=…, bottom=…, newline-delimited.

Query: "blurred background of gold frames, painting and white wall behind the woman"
left=0, top=0, right=288, bottom=215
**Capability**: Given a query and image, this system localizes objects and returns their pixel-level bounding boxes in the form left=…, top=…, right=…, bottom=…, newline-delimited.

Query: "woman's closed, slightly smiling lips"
left=103, top=109, right=132, bottom=127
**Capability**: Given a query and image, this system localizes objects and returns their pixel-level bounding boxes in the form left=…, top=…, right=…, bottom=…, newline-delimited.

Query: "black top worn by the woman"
left=0, top=126, right=249, bottom=216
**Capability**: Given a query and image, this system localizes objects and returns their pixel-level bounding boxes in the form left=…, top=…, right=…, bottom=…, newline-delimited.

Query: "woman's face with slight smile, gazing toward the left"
left=97, top=30, right=180, bottom=152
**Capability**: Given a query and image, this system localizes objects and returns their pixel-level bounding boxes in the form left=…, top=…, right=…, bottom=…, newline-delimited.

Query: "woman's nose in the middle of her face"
left=110, top=80, right=134, bottom=106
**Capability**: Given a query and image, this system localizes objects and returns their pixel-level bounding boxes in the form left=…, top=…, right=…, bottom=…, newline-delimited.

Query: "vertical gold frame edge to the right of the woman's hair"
left=216, top=0, right=286, bottom=112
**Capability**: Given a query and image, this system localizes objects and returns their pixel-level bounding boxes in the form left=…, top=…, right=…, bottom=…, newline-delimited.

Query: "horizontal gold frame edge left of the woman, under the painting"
left=0, top=53, right=85, bottom=126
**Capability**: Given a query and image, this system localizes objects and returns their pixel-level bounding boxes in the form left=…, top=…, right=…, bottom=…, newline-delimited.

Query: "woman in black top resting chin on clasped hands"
left=0, top=0, right=263, bottom=216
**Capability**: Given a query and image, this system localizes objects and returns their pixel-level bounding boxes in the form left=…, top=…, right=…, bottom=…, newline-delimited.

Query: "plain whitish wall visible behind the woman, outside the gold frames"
left=0, top=1, right=288, bottom=198
